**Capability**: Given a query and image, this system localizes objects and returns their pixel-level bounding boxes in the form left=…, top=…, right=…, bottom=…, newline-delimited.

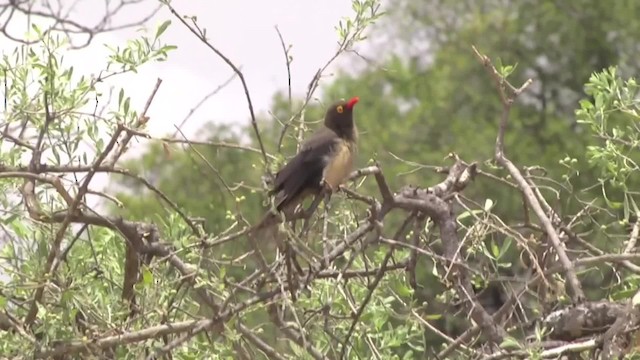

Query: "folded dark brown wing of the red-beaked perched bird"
left=273, top=129, right=339, bottom=210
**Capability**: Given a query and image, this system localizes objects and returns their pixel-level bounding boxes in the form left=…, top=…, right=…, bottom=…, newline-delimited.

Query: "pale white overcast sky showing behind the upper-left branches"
left=41, top=0, right=364, bottom=135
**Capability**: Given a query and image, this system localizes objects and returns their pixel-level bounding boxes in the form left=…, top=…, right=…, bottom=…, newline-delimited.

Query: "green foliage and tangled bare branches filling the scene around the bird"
left=0, top=0, right=640, bottom=359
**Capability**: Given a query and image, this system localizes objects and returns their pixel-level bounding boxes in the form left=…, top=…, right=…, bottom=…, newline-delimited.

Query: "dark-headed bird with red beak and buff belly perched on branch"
left=254, top=97, right=359, bottom=231
